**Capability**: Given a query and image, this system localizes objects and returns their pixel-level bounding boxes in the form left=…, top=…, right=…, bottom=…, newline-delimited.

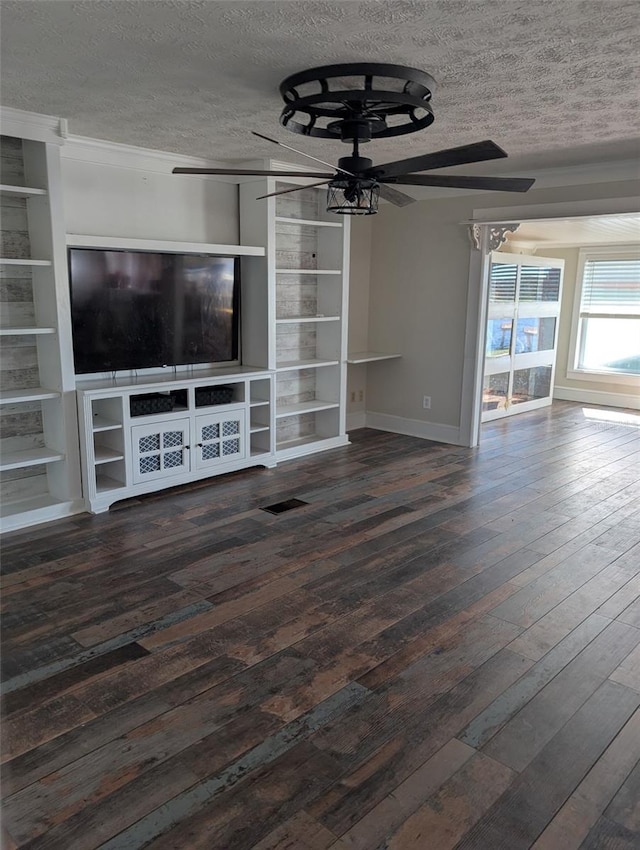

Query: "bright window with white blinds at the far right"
left=572, top=247, right=640, bottom=380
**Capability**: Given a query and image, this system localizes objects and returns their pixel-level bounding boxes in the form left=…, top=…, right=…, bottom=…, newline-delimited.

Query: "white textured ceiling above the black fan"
left=1, top=0, right=640, bottom=173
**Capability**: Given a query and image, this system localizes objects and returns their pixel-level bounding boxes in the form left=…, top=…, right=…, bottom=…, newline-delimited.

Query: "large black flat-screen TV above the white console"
left=69, top=248, right=240, bottom=374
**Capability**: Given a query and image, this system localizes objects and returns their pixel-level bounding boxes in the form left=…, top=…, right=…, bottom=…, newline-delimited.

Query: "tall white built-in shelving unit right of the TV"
left=240, top=179, right=349, bottom=460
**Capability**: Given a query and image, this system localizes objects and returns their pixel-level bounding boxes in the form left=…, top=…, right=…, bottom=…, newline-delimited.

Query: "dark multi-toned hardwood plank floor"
left=2, top=402, right=640, bottom=850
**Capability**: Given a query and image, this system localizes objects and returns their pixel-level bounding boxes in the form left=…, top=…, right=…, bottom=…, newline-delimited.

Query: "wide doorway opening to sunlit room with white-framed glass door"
left=463, top=212, right=640, bottom=445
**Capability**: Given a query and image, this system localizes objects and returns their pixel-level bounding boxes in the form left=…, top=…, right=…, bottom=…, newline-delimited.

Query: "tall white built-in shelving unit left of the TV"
left=0, top=121, right=82, bottom=530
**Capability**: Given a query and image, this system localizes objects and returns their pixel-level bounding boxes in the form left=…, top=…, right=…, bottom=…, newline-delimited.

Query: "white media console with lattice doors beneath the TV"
left=77, top=366, right=276, bottom=513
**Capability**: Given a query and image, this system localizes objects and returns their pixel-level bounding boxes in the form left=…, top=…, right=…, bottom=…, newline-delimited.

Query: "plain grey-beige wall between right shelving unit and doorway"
left=367, top=175, right=638, bottom=439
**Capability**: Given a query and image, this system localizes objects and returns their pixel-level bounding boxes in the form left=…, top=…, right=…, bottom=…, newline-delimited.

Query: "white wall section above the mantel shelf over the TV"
left=62, top=143, right=239, bottom=245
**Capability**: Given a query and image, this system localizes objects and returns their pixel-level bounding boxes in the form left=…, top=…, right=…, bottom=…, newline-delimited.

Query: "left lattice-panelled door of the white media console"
left=131, top=419, right=191, bottom=484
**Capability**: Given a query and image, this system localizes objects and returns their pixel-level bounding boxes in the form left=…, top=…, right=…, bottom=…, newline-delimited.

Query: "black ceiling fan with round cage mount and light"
left=173, top=63, right=535, bottom=215
